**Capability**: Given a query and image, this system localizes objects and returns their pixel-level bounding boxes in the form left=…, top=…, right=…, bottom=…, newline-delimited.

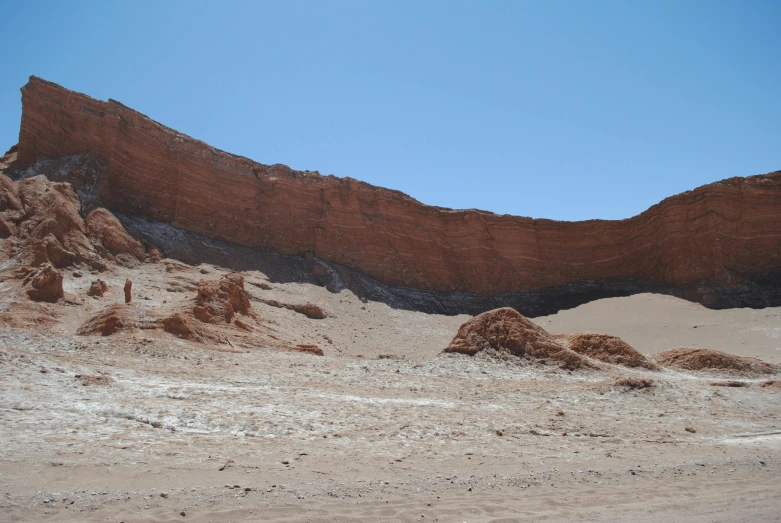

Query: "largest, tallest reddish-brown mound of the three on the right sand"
left=443, top=307, right=591, bottom=369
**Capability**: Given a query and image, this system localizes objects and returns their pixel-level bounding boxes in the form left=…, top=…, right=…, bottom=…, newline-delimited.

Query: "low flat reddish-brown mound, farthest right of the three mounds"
left=654, top=347, right=776, bottom=374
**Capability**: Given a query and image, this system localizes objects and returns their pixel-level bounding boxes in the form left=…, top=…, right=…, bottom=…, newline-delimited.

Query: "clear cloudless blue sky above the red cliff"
left=0, top=0, right=781, bottom=220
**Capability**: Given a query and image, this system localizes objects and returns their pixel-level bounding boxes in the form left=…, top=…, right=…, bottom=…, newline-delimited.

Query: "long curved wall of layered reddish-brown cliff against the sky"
left=10, top=77, right=781, bottom=306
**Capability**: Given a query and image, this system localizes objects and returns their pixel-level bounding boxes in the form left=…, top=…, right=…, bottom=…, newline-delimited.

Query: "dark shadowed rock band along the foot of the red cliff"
left=118, top=208, right=781, bottom=317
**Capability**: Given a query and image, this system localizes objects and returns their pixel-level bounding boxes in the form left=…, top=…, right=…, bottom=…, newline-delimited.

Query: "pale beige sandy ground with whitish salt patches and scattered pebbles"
left=0, top=263, right=781, bottom=522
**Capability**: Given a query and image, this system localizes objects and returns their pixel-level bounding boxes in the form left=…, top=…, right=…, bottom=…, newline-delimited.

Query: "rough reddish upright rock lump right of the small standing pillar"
left=193, top=274, right=251, bottom=323
